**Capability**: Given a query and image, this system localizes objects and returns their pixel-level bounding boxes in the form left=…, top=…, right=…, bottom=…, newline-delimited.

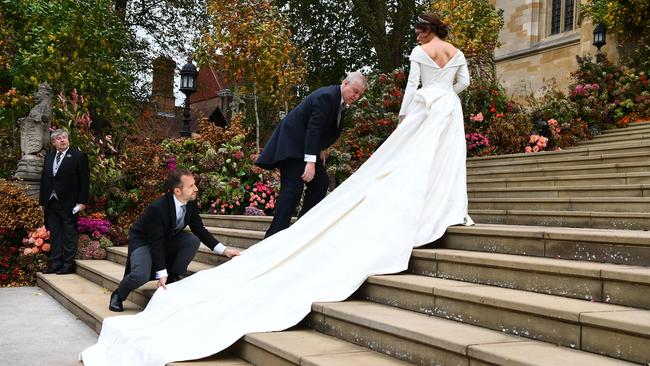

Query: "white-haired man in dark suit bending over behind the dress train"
left=255, top=72, right=367, bottom=237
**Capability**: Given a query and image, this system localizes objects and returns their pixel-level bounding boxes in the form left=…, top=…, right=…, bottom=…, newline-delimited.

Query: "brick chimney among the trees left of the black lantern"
left=151, top=56, right=176, bottom=114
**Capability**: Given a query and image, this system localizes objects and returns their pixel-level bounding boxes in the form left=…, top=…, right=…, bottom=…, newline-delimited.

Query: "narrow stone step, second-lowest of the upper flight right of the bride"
left=469, top=197, right=650, bottom=213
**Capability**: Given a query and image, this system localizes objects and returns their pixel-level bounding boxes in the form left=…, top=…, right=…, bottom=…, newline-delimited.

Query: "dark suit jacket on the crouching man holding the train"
left=126, top=192, right=219, bottom=273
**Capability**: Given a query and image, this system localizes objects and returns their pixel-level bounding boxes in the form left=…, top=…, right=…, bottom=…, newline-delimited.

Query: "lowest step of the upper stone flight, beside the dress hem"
left=469, top=209, right=650, bottom=230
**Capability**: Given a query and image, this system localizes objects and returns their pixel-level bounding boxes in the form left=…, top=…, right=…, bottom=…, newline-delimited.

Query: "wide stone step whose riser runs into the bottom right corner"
left=357, top=275, right=650, bottom=363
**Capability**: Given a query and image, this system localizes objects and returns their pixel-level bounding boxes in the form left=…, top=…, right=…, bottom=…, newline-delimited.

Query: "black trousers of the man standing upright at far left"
left=45, top=198, right=79, bottom=269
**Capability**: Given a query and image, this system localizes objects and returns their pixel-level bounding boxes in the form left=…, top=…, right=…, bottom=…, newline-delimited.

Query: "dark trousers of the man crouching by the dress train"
left=117, top=231, right=201, bottom=300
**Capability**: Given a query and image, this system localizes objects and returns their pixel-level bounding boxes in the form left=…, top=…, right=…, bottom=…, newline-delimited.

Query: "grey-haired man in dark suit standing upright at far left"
left=39, top=130, right=90, bottom=274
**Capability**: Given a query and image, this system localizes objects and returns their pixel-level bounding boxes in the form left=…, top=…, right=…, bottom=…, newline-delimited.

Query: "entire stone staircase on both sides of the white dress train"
left=38, top=124, right=650, bottom=366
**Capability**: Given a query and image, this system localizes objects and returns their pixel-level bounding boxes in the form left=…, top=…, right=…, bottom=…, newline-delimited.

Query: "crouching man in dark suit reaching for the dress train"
left=108, top=170, right=239, bottom=311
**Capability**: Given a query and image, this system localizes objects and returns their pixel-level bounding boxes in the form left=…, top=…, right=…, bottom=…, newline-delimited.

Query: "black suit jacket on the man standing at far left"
left=38, top=148, right=90, bottom=212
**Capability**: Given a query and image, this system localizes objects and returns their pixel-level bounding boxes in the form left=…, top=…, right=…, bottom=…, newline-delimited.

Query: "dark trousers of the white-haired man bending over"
left=264, top=157, right=330, bottom=238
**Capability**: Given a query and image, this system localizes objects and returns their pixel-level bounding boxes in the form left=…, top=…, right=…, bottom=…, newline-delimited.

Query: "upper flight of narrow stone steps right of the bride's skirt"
left=467, top=122, right=650, bottom=230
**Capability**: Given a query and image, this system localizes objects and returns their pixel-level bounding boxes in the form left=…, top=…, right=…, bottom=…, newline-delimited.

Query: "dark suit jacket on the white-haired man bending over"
left=255, top=85, right=344, bottom=170
